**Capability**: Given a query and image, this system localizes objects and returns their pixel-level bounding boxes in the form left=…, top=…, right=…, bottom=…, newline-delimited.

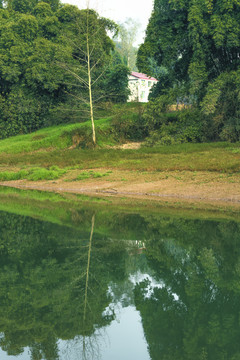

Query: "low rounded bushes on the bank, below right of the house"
left=143, top=99, right=219, bottom=146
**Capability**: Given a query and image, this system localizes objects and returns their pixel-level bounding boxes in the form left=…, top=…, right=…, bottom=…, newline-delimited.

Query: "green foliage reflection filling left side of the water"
left=0, top=213, right=125, bottom=360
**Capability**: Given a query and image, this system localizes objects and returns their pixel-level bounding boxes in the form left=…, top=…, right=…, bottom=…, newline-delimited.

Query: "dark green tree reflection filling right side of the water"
left=135, top=218, right=240, bottom=360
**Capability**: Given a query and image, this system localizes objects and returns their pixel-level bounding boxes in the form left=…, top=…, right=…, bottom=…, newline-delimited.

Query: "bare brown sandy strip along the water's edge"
left=0, top=169, right=240, bottom=209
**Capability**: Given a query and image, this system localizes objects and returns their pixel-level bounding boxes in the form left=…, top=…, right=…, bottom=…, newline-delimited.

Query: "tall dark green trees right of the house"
left=137, top=0, right=240, bottom=141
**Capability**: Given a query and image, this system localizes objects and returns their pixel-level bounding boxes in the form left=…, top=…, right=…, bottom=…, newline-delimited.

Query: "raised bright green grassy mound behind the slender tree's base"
left=0, top=103, right=142, bottom=154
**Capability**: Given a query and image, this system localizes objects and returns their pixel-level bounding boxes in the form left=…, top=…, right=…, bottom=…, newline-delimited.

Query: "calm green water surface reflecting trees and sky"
left=0, top=190, right=240, bottom=360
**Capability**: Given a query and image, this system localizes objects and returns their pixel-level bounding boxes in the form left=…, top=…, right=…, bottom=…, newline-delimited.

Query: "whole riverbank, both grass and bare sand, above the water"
left=0, top=119, right=240, bottom=209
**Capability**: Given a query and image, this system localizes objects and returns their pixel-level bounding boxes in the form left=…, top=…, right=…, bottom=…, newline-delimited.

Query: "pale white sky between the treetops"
left=62, top=0, right=153, bottom=43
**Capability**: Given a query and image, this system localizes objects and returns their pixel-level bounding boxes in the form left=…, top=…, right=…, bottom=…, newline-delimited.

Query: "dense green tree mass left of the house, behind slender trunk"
left=0, top=0, right=128, bottom=138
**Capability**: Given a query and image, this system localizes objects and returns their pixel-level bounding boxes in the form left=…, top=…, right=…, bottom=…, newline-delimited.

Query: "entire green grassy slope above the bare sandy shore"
left=0, top=118, right=240, bottom=180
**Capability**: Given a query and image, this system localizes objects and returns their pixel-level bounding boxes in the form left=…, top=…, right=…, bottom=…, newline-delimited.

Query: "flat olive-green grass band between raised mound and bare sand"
left=0, top=143, right=240, bottom=173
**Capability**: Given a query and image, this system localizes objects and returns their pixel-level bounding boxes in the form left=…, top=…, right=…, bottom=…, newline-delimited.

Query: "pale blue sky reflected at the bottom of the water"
left=0, top=303, right=150, bottom=360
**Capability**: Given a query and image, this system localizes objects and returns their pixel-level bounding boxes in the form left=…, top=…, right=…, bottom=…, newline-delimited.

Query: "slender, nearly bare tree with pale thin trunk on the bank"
left=58, top=1, right=117, bottom=145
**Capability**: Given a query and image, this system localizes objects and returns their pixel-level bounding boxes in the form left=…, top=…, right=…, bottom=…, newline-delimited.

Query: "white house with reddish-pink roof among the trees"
left=128, top=71, right=158, bottom=102
